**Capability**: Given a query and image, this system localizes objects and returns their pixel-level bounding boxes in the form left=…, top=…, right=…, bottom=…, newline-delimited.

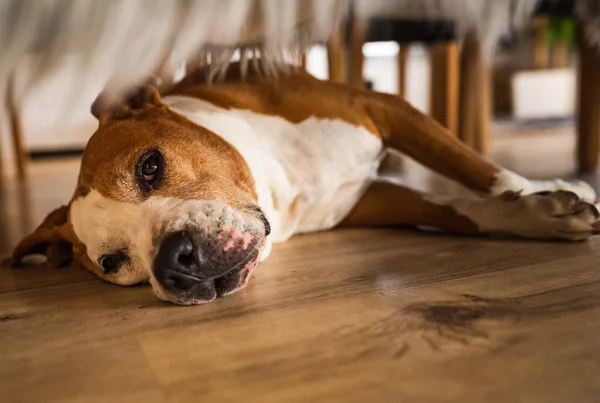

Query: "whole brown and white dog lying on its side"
left=13, top=67, right=598, bottom=304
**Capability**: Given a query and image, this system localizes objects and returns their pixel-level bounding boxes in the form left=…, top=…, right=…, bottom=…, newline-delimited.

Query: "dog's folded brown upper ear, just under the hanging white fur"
left=92, top=77, right=163, bottom=125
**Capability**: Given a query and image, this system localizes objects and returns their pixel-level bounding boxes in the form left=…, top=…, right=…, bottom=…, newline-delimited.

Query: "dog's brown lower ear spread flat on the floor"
left=11, top=206, right=74, bottom=268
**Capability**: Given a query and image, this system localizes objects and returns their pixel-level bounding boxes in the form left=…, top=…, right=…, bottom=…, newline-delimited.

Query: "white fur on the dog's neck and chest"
left=165, top=96, right=383, bottom=242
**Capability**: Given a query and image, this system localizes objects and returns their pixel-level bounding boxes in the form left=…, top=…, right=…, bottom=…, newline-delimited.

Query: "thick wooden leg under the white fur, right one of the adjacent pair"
left=459, top=33, right=492, bottom=154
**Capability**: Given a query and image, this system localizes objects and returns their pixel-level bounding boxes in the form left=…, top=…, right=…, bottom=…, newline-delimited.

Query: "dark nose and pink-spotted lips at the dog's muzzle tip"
left=153, top=230, right=262, bottom=303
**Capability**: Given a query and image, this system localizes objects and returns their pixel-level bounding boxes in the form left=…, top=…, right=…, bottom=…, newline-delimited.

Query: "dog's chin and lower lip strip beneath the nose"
left=152, top=251, right=259, bottom=305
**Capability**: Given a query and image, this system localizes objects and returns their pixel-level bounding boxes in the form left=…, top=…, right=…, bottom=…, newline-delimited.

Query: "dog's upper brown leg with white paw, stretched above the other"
left=362, top=91, right=596, bottom=202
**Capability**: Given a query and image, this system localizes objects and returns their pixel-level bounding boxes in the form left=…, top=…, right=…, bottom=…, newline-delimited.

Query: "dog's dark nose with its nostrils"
left=154, top=232, right=200, bottom=291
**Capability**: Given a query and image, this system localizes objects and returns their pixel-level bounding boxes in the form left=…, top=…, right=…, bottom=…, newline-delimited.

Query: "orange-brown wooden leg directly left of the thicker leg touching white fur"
left=429, top=42, right=460, bottom=133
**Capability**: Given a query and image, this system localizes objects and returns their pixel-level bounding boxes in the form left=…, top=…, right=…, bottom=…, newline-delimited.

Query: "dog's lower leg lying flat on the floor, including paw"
left=340, top=182, right=599, bottom=241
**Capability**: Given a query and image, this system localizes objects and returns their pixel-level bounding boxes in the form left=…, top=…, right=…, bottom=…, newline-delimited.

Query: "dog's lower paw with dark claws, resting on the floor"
left=488, top=190, right=600, bottom=241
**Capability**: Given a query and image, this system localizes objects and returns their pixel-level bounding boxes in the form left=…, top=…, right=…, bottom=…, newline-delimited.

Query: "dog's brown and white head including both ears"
left=13, top=85, right=270, bottom=304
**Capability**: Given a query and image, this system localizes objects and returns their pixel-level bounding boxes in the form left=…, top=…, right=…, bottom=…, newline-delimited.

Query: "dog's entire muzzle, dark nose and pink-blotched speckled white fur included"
left=151, top=202, right=270, bottom=305
